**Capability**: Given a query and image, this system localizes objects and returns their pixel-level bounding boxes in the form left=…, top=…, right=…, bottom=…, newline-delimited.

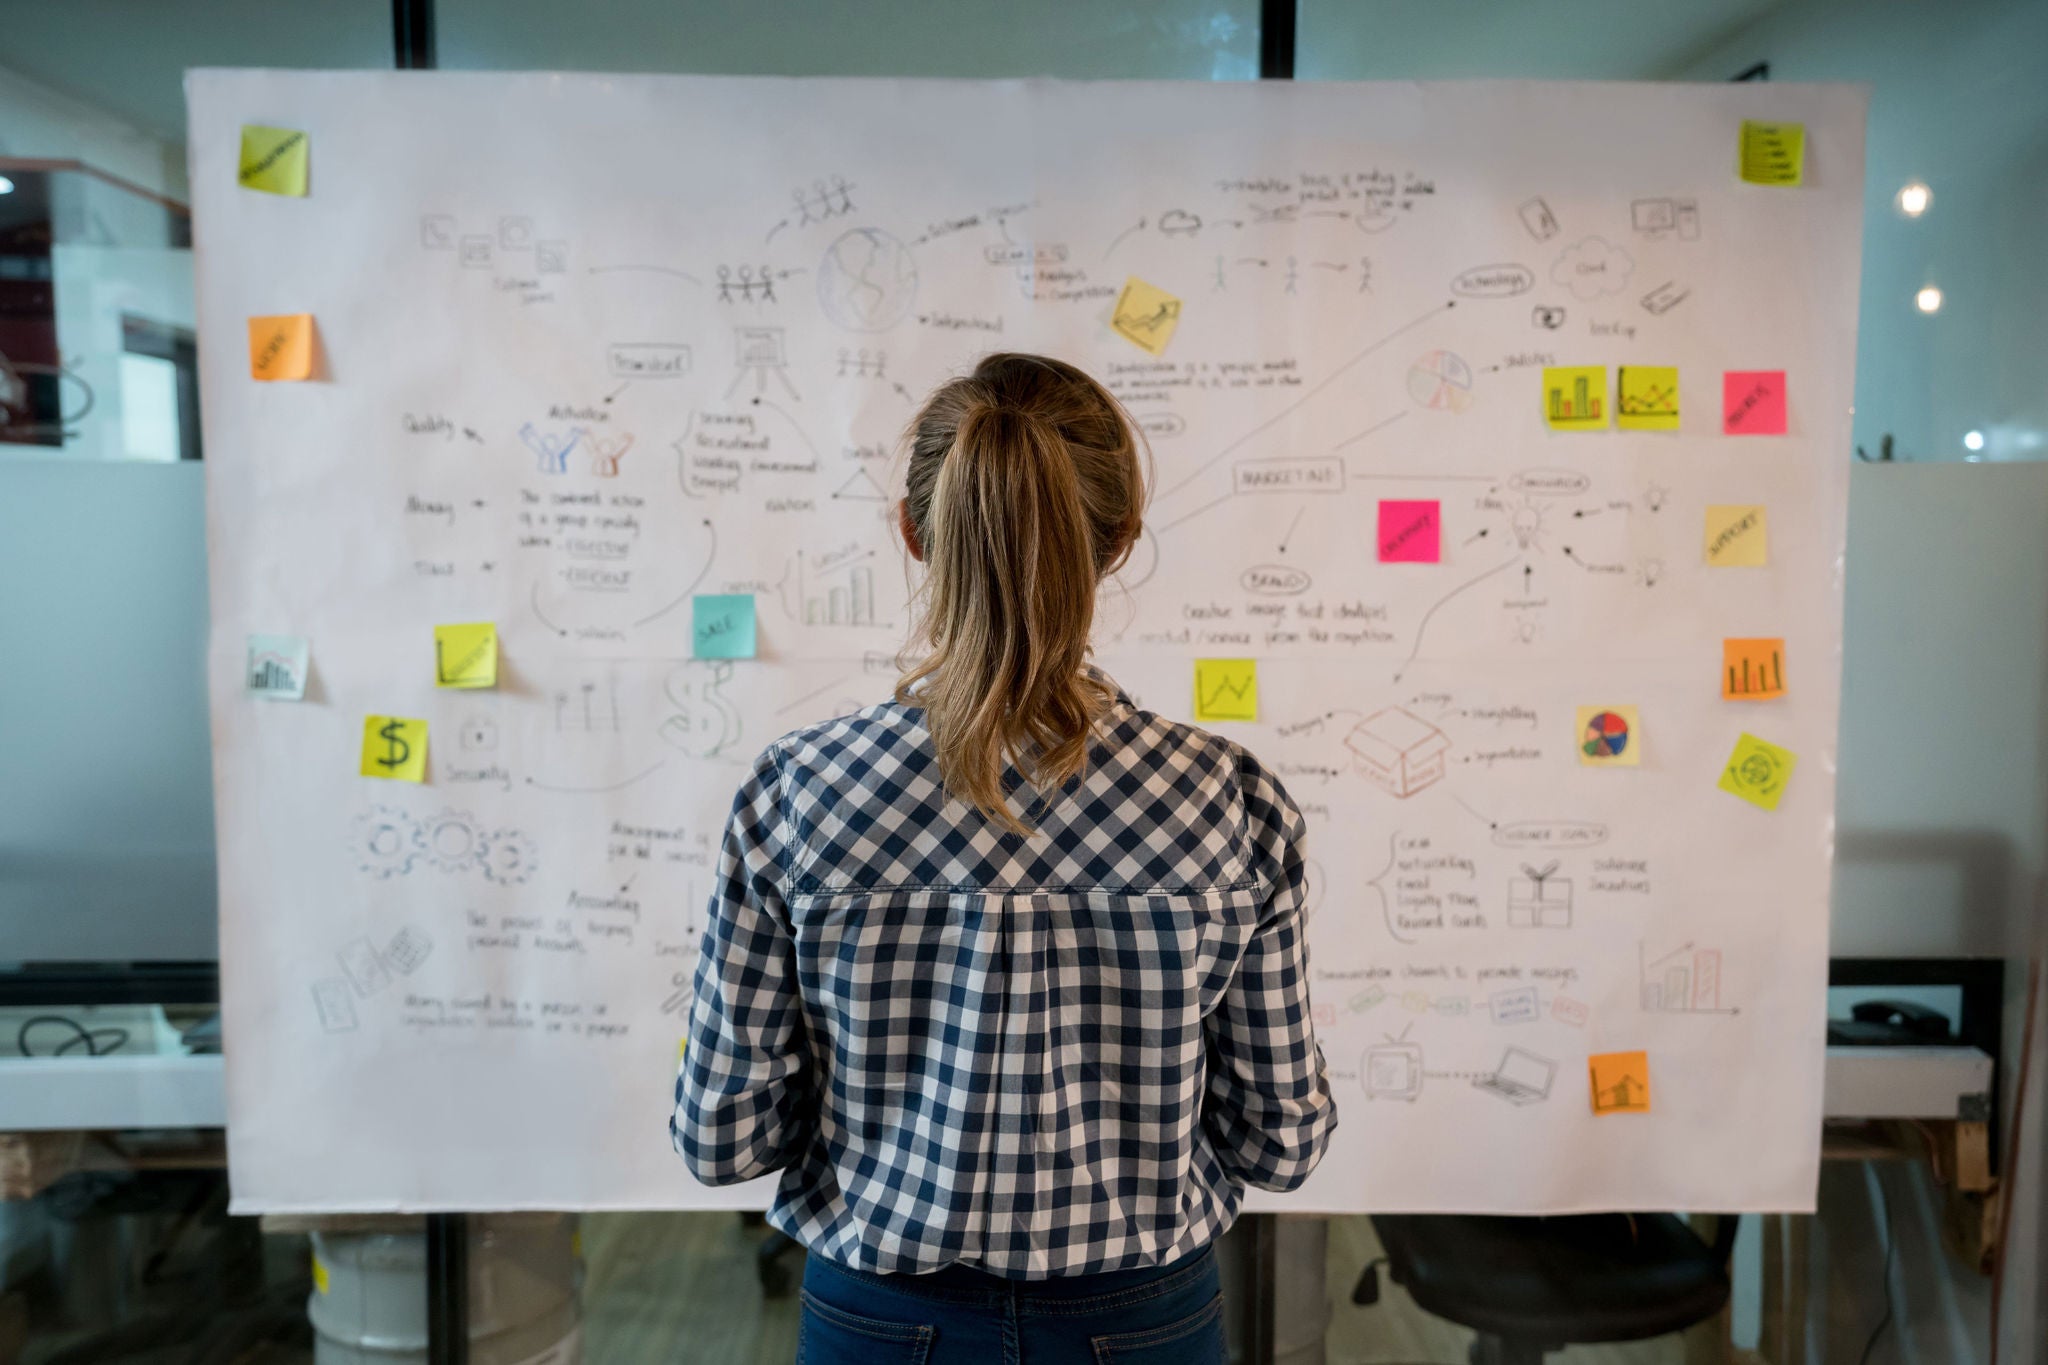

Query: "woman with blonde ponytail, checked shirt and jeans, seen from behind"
left=672, top=354, right=1335, bottom=1365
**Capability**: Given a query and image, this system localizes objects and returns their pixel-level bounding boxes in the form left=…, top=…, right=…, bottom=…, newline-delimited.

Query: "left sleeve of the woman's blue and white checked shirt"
left=670, top=749, right=817, bottom=1185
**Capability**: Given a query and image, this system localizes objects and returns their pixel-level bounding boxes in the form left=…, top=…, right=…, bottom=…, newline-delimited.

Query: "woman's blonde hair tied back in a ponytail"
left=897, top=354, right=1145, bottom=833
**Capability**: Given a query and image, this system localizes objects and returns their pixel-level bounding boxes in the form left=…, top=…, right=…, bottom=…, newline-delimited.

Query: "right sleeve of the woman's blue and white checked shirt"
left=1202, top=751, right=1337, bottom=1191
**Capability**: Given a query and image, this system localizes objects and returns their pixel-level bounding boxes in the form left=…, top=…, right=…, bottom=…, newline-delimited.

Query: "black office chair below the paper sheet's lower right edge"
left=1352, top=1214, right=1741, bottom=1365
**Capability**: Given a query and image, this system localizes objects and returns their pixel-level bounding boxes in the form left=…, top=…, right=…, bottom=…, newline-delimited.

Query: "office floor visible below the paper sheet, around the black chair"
left=584, top=1214, right=1686, bottom=1365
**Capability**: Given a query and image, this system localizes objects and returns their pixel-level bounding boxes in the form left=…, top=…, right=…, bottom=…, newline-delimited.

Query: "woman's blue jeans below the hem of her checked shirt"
left=797, top=1246, right=1225, bottom=1365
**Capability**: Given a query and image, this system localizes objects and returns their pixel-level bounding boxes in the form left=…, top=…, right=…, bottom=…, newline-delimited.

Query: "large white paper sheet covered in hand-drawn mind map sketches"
left=193, top=72, right=1862, bottom=1212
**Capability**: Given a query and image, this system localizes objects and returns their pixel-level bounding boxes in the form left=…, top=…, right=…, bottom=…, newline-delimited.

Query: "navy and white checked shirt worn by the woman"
left=670, top=671, right=1337, bottom=1279
